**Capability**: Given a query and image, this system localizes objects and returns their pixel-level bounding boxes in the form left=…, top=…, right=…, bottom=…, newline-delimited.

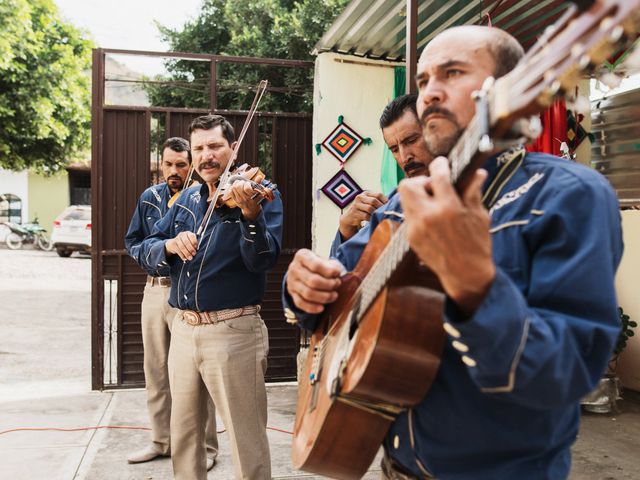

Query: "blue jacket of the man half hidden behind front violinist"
left=124, top=183, right=172, bottom=277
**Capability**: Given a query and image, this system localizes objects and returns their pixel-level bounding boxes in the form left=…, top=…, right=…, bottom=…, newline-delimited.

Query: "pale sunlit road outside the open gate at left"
left=0, top=248, right=91, bottom=401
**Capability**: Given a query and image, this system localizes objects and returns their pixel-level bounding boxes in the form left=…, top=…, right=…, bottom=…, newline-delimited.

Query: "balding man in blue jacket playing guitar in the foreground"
left=283, top=26, right=622, bottom=479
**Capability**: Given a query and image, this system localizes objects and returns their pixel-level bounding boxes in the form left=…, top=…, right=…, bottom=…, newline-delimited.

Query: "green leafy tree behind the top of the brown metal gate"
left=145, top=0, right=348, bottom=112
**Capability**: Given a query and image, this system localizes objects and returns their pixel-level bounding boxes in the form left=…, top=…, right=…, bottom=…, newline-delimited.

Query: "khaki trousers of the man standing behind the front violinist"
left=142, top=284, right=218, bottom=458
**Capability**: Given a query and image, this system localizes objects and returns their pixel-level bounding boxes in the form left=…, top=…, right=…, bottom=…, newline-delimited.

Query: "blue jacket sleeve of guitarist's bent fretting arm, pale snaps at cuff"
left=444, top=176, right=622, bottom=408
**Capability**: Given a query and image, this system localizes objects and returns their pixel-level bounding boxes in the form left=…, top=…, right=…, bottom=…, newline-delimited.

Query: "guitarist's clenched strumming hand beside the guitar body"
left=287, top=248, right=344, bottom=313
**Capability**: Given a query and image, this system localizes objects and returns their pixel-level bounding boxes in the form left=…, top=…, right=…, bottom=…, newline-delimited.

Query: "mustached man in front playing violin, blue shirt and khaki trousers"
left=142, top=115, right=283, bottom=480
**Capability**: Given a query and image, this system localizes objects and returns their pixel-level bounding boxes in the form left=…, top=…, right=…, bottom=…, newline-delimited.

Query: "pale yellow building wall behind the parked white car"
left=23, top=172, right=69, bottom=235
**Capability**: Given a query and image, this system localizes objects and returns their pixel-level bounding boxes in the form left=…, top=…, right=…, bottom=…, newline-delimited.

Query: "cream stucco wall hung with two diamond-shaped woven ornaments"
left=311, top=53, right=394, bottom=255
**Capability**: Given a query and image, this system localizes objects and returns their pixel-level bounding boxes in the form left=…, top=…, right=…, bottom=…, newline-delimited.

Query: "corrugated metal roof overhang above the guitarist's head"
left=315, top=0, right=570, bottom=61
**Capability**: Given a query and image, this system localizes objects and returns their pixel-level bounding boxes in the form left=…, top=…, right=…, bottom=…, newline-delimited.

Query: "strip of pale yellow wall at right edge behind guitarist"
left=616, top=210, right=640, bottom=391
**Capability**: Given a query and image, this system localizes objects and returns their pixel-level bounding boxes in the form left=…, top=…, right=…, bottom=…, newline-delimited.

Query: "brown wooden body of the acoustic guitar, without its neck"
left=292, top=220, right=444, bottom=479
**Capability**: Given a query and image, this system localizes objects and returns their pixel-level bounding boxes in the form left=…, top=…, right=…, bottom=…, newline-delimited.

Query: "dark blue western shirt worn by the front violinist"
left=142, top=181, right=282, bottom=312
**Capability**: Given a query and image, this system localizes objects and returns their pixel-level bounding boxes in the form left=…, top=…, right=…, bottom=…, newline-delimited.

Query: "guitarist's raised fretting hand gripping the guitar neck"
left=398, top=157, right=496, bottom=315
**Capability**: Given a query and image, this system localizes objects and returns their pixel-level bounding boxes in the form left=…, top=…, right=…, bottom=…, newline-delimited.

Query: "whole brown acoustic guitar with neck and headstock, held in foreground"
left=292, top=0, right=640, bottom=479
